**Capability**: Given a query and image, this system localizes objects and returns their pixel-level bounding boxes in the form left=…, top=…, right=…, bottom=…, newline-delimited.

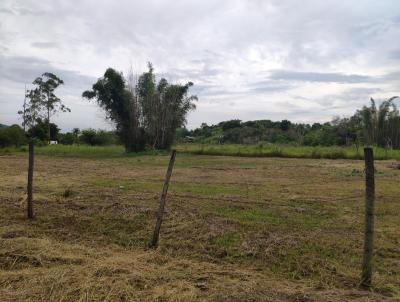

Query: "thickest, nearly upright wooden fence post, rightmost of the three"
left=361, top=148, right=375, bottom=288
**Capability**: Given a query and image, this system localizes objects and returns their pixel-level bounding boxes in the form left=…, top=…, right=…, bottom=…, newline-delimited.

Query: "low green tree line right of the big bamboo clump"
left=178, top=98, right=400, bottom=149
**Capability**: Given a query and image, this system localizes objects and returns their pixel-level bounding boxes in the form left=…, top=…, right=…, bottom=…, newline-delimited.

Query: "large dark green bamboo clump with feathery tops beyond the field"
left=83, top=64, right=196, bottom=152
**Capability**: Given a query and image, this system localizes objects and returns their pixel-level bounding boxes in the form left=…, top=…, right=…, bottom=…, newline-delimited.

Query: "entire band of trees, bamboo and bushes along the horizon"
left=0, top=63, right=400, bottom=152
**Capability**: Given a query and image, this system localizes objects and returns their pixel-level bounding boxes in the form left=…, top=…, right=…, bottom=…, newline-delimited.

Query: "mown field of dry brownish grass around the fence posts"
left=0, top=154, right=400, bottom=301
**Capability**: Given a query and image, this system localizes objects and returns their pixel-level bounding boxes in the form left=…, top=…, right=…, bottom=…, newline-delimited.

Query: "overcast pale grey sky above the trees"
left=0, top=0, right=400, bottom=130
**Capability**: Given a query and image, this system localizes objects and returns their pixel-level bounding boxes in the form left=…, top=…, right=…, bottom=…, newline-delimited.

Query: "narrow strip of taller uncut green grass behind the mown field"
left=0, top=144, right=400, bottom=160
